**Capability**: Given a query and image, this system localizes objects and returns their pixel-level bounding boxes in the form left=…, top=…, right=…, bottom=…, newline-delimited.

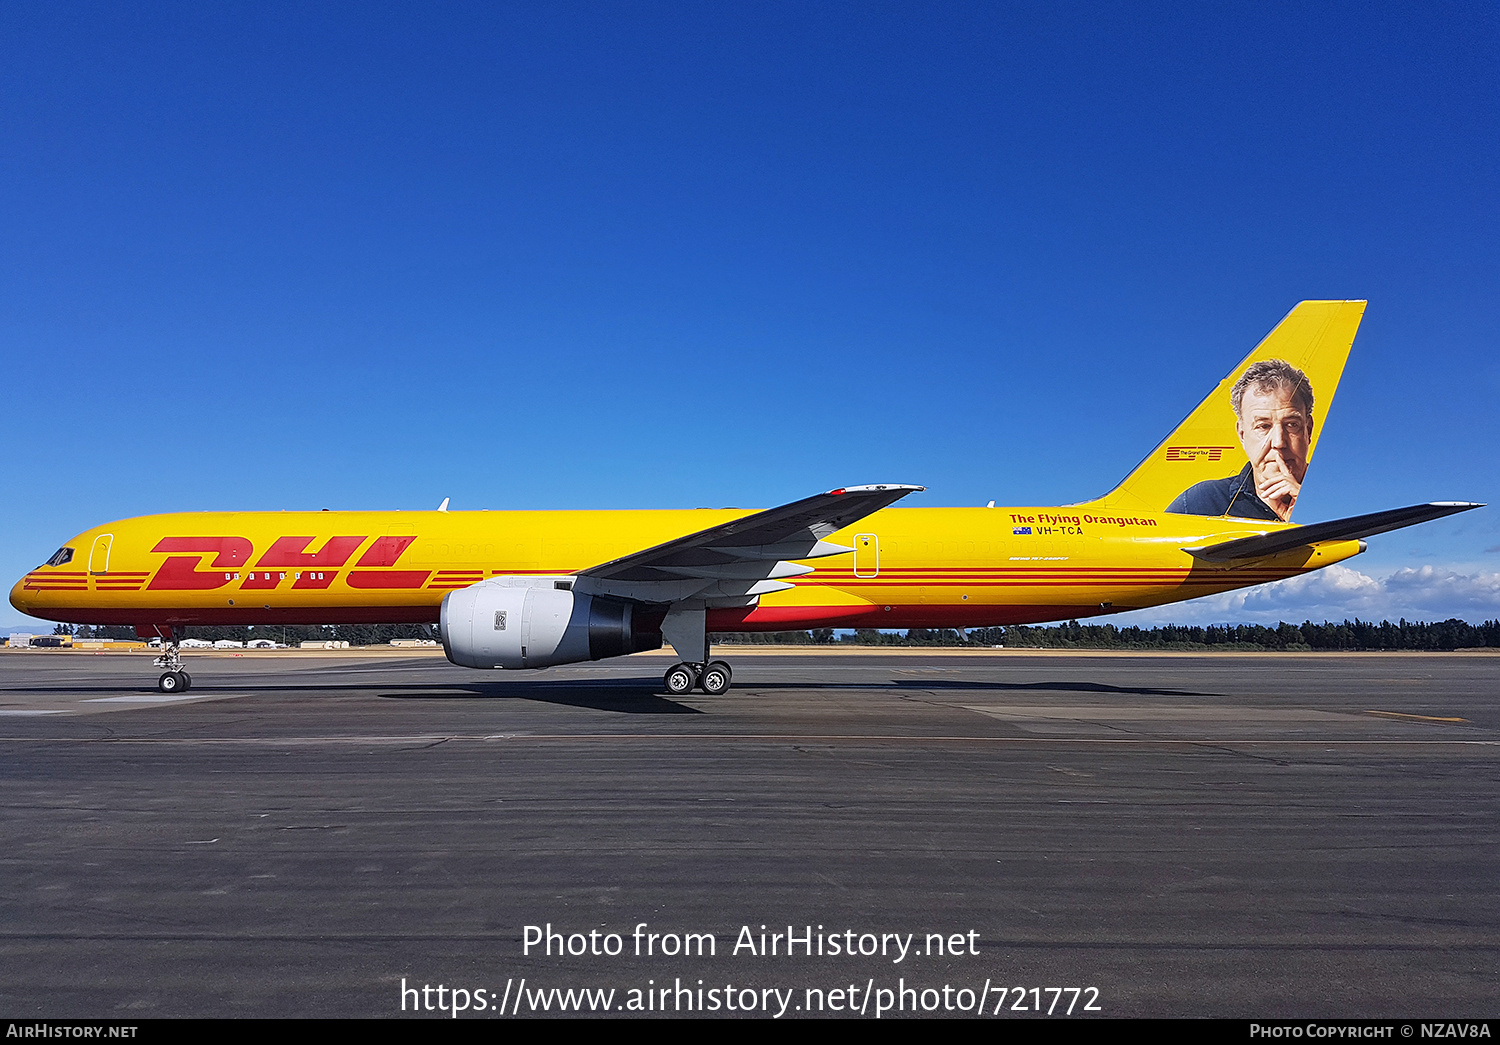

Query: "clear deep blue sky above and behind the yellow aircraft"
left=0, top=3, right=1500, bottom=621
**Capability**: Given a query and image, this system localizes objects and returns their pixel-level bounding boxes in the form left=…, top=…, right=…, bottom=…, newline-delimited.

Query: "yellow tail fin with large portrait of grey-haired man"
left=1094, top=301, right=1365, bottom=520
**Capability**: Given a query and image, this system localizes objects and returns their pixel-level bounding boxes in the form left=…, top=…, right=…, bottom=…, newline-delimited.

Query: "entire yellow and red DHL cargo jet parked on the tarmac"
left=11, top=301, right=1481, bottom=694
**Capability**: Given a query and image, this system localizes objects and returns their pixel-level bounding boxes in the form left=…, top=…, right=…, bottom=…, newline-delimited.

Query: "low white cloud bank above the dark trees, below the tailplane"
left=1113, top=565, right=1500, bottom=625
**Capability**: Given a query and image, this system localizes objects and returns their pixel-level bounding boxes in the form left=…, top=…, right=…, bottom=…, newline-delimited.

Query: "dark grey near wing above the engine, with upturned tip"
left=573, top=484, right=927, bottom=606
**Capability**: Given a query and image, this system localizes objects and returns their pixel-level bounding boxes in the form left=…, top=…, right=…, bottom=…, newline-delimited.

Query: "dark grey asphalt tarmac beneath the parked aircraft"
left=0, top=648, right=1500, bottom=1020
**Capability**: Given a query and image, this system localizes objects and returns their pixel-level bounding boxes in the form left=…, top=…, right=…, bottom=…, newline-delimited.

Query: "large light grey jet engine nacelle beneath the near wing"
left=440, top=577, right=662, bottom=667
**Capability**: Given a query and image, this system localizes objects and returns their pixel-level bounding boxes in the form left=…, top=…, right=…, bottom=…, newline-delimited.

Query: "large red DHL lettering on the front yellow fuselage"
left=146, top=534, right=432, bottom=591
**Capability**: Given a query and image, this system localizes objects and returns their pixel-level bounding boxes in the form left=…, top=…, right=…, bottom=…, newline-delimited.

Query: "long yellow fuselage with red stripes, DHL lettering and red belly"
left=11, top=505, right=1362, bottom=631
